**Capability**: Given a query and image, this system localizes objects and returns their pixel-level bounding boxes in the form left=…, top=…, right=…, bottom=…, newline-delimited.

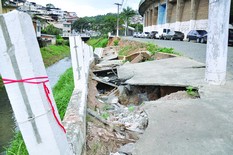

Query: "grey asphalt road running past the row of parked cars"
left=123, top=37, right=233, bottom=73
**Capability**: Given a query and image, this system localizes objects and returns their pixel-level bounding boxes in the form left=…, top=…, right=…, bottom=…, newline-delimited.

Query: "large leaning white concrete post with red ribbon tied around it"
left=0, top=11, right=72, bottom=155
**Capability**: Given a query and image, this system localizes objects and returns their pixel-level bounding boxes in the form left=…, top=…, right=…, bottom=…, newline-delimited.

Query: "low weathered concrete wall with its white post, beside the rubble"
left=63, top=36, right=94, bottom=155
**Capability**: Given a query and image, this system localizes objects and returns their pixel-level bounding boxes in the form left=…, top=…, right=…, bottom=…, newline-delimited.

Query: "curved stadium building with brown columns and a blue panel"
left=139, top=0, right=209, bottom=35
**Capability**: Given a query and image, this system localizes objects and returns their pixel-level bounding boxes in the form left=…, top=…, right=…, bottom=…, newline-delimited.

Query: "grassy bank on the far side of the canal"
left=40, top=45, right=70, bottom=67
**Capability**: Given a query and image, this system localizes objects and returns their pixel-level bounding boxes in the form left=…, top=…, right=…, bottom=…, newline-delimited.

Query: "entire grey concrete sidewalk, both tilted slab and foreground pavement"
left=118, top=57, right=233, bottom=155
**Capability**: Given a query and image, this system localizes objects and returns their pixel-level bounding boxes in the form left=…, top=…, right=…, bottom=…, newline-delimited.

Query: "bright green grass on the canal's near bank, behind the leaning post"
left=7, top=68, right=74, bottom=155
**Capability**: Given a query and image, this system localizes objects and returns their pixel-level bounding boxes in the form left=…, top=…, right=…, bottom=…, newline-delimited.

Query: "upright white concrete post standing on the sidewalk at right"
left=205, top=0, right=231, bottom=85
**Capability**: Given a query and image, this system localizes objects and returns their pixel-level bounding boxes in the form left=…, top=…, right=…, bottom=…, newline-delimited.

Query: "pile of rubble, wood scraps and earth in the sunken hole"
left=87, top=39, right=199, bottom=155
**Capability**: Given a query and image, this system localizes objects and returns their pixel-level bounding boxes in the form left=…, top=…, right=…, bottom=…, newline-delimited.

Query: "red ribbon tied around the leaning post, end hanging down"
left=2, top=76, right=66, bottom=133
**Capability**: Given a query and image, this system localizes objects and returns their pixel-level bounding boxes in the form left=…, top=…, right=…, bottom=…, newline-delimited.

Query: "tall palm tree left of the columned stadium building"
left=121, top=7, right=136, bottom=36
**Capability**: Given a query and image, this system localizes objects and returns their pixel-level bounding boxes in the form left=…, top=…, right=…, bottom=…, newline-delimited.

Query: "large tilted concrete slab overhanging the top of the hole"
left=117, top=57, right=205, bottom=87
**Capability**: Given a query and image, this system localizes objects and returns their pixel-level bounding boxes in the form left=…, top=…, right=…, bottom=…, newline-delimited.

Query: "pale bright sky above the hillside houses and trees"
left=28, top=0, right=140, bottom=17
